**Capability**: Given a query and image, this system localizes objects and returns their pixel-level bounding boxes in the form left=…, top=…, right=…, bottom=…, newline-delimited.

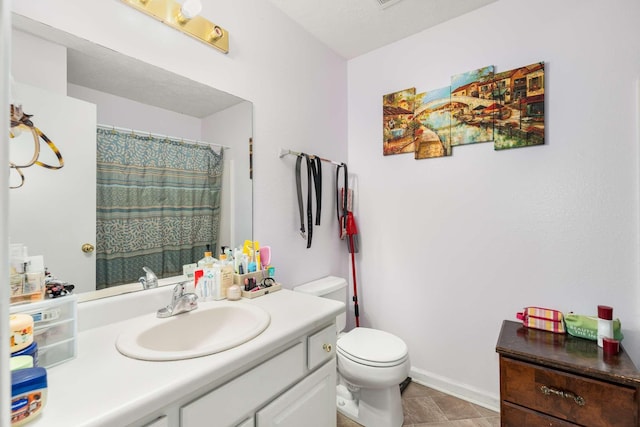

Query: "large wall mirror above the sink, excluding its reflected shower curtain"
left=9, top=14, right=253, bottom=299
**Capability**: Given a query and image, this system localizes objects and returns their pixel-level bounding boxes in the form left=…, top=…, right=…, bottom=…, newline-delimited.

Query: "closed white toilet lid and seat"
left=337, top=328, right=408, bottom=365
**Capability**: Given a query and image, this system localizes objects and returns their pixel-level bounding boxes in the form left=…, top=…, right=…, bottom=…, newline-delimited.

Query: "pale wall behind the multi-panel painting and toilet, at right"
left=348, top=0, right=640, bottom=407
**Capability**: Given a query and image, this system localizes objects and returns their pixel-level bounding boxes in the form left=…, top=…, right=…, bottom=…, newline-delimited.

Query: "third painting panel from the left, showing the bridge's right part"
left=451, top=65, right=501, bottom=146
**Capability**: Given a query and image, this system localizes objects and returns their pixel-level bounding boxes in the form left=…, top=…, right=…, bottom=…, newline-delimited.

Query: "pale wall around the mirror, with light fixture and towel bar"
left=12, top=0, right=348, bottom=287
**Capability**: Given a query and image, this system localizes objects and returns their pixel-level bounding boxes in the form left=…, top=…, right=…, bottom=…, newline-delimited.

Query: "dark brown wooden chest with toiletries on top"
left=496, top=320, right=640, bottom=427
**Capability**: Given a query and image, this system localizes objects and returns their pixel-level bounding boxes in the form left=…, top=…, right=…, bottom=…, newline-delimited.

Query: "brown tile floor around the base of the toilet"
left=338, top=382, right=500, bottom=427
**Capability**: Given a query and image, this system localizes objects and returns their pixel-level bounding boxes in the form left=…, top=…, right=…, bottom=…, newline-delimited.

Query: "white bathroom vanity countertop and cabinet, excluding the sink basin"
left=30, top=287, right=345, bottom=427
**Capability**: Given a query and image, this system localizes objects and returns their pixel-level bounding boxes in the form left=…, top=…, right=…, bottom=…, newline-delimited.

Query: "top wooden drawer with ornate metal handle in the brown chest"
left=500, top=357, right=638, bottom=427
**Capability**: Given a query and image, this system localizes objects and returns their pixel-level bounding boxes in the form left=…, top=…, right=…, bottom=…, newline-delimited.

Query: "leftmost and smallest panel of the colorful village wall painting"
left=382, top=88, right=416, bottom=156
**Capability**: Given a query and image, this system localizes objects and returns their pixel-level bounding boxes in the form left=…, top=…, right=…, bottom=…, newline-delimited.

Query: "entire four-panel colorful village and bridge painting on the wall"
left=382, top=62, right=544, bottom=159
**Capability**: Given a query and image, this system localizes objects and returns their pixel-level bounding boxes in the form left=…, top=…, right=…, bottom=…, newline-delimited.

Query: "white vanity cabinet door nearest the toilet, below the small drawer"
left=256, top=358, right=336, bottom=427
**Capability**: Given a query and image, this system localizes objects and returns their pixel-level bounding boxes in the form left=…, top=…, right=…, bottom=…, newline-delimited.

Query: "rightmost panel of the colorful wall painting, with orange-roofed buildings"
left=493, top=62, right=544, bottom=150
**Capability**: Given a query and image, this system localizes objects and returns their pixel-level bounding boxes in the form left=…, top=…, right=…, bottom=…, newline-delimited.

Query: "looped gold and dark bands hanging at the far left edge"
left=9, top=104, right=64, bottom=189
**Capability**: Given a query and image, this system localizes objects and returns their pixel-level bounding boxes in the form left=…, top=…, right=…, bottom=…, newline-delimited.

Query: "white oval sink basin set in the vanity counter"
left=116, top=301, right=271, bottom=360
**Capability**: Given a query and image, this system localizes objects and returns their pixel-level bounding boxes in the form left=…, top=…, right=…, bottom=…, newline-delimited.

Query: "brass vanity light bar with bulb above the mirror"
left=122, top=0, right=229, bottom=53
